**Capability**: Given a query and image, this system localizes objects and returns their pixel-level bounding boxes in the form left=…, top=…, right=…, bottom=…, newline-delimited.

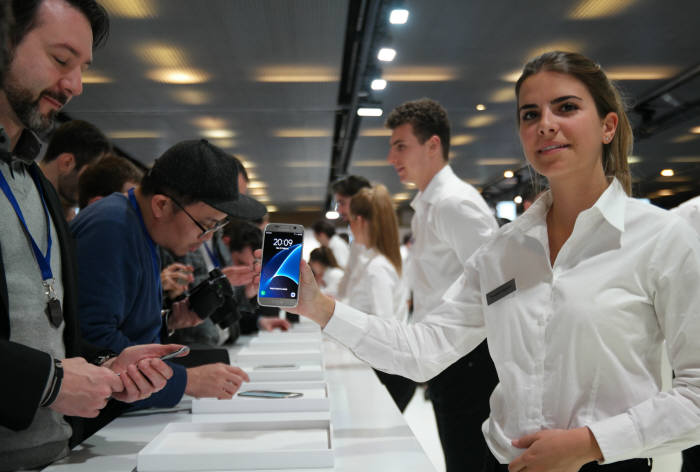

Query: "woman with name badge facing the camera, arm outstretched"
left=284, top=52, right=700, bottom=472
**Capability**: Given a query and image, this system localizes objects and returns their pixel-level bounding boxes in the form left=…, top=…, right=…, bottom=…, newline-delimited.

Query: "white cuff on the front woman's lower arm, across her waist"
left=588, top=413, right=643, bottom=464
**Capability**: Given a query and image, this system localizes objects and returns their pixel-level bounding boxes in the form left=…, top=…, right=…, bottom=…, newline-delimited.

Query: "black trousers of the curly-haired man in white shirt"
left=428, top=341, right=498, bottom=472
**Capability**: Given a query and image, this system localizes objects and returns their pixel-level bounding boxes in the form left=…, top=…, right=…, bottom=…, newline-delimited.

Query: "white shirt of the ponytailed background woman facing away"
left=344, top=243, right=408, bottom=321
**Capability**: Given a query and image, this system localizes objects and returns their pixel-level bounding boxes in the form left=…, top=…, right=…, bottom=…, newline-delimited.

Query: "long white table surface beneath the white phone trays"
left=44, top=325, right=435, bottom=472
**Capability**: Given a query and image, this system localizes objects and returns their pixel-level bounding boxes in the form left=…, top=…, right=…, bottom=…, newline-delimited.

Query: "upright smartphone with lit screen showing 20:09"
left=258, top=223, right=304, bottom=308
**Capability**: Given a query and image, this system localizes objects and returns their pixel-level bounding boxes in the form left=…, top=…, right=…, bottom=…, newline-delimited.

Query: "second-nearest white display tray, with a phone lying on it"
left=192, top=382, right=331, bottom=414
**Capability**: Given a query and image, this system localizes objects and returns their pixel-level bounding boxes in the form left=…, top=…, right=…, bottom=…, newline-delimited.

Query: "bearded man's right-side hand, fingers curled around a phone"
left=103, top=344, right=187, bottom=403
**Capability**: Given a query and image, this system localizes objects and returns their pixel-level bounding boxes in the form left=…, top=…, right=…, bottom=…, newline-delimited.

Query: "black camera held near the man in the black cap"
left=189, top=269, right=241, bottom=328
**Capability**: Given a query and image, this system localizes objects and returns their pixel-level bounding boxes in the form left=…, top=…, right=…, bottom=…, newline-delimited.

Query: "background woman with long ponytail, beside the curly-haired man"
left=344, top=184, right=416, bottom=412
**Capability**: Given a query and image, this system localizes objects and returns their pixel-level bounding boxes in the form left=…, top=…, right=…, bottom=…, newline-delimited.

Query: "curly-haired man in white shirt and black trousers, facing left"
left=386, top=99, right=498, bottom=472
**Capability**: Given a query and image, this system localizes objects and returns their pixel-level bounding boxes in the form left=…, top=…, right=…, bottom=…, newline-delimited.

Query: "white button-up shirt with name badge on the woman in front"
left=325, top=180, right=700, bottom=463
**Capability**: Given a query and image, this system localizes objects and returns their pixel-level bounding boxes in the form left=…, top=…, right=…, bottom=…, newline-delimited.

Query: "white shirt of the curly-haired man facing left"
left=405, top=165, right=498, bottom=322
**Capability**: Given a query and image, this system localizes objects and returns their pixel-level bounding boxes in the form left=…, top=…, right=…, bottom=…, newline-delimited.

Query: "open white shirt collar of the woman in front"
left=514, top=179, right=627, bottom=233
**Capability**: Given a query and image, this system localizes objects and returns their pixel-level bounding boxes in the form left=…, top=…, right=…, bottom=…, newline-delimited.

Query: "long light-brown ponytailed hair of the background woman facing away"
left=350, top=184, right=401, bottom=275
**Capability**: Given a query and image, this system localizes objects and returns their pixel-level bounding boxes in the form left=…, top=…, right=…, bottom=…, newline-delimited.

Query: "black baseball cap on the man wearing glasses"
left=148, top=139, right=267, bottom=220
